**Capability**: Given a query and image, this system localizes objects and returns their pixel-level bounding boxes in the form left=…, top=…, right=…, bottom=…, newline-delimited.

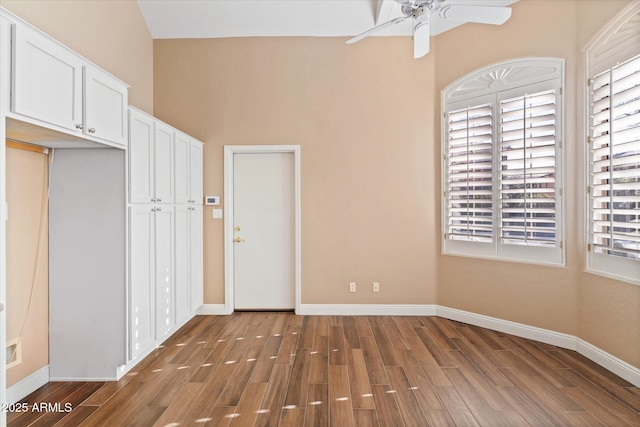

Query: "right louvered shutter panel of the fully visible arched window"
left=500, top=90, right=557, bottom=247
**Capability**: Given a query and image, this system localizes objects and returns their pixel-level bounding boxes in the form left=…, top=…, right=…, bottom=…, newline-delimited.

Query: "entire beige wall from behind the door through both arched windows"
left=154, top=0, right=640, bottom=366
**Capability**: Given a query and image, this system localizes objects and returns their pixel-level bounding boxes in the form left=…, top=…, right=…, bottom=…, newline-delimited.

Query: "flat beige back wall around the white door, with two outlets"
left=154, top=37, right=438, bottom=304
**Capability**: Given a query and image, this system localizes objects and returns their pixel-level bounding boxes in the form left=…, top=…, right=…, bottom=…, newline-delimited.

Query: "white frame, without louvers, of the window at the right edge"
left=583, top=2, right=640, bottom=285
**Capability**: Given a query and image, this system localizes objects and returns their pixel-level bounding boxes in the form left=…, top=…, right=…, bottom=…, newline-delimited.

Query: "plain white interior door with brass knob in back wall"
left=233, top=153, right=295, bottom=310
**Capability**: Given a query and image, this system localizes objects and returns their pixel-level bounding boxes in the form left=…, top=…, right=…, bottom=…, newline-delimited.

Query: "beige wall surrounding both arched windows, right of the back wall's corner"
left=436, top=0, right=640, bottom=366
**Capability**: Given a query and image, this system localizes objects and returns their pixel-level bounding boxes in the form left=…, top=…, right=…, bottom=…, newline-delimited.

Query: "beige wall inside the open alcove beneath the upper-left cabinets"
left=7, top=148, right=49, bottom=387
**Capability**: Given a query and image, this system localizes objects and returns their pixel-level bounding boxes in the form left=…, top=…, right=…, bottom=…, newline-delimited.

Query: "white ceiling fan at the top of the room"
left=347, top=0, right=511, bottom=58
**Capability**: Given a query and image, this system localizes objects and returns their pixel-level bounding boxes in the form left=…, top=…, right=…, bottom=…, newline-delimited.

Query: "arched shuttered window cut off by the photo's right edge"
left=586, top=2, right=640, bottom=282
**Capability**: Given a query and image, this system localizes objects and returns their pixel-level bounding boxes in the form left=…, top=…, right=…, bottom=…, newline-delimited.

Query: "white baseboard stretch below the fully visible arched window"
left=436, top=306, right=576, bottom=350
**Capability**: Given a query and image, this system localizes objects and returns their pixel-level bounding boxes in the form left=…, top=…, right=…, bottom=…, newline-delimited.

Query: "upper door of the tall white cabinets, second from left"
left=153, top=122, right=173, bottom=204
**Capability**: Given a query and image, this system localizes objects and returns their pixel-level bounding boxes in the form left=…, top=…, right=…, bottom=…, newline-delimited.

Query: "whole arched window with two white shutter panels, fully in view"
left=443, top=58, right=564, bottom=264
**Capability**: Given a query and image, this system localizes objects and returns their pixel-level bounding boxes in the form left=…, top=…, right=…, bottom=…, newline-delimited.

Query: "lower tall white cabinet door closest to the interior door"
left=189, top=205, right=204, bottom=312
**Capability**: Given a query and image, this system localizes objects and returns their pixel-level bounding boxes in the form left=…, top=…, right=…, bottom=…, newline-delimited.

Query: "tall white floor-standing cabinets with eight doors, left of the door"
left=129, top=108, right=203, bottom=360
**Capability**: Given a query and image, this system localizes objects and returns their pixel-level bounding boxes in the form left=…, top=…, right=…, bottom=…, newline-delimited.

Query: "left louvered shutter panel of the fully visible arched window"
left=446, top=104, right=493, bottom=242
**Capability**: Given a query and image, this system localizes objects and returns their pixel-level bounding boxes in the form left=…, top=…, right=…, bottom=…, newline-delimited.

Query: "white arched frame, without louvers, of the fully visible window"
left=441, top=58, right=566, bottom=267
